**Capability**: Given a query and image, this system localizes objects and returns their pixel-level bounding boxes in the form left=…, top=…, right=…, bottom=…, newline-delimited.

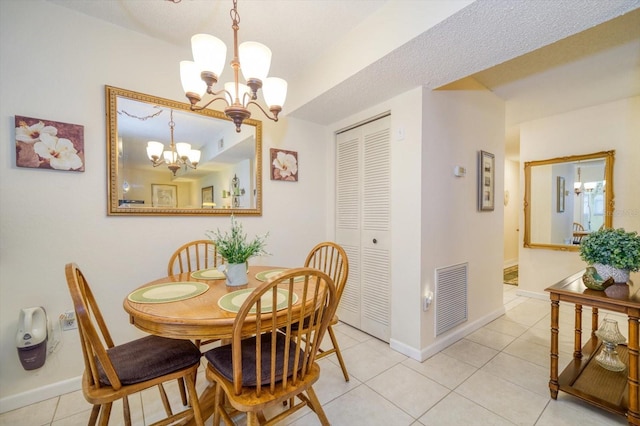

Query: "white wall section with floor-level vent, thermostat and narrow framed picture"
left=420, top=91, right=505, bottom=358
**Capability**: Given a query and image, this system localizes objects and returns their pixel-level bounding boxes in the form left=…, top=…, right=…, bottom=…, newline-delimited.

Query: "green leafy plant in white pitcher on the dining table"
left=207, top=215, right=269, bottom=286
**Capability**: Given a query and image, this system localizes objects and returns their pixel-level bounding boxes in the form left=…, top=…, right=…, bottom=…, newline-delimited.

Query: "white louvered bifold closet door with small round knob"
left=336, top=116, right=391, bottom=341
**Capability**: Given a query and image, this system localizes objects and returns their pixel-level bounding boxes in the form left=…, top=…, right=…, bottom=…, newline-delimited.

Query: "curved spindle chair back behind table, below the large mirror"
left=167, top=240, right=222, bottom=275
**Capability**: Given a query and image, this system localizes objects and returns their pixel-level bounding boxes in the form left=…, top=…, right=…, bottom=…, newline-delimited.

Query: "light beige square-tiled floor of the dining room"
left=0, top=285, right=627, bottom=426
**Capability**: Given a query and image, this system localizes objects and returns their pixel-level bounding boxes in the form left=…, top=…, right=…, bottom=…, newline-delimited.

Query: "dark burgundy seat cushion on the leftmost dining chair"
left=98, top=336, right=201, bottom=386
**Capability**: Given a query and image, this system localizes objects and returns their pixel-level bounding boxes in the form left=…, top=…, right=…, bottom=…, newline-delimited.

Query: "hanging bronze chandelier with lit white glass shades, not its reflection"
left=180, top=0, right=287, bottom=132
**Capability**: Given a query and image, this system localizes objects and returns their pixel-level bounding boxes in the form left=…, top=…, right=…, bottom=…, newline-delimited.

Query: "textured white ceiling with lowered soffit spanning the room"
left=49, top=0, right=640, bottom=156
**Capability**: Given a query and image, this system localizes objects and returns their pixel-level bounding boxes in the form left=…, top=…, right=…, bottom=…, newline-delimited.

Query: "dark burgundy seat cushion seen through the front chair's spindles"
left=204, top=333, right=303, bottom=386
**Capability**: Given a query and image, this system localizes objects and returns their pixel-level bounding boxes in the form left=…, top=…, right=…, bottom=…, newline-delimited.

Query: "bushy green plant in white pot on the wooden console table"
left=580, top=228, right=640, bottom=283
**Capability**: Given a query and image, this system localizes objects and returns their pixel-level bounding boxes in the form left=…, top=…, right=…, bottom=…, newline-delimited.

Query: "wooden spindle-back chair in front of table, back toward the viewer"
left=205, top=268, right=337, bottom=426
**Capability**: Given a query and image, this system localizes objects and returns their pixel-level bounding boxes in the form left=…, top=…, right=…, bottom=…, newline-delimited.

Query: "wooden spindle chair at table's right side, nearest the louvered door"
left=304, top=241, right=349, bottom=382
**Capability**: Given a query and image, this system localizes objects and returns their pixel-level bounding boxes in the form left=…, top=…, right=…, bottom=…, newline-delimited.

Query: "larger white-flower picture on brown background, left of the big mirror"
left=15, top=115, right=84, bottom=172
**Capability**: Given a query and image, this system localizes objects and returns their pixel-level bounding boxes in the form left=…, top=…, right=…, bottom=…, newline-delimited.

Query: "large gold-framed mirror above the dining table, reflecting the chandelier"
left=105, top=86, right=262, bottom=216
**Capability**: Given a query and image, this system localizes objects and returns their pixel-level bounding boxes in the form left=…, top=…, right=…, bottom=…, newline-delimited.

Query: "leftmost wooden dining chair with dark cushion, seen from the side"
left=65, top=263, right=204, bottom=426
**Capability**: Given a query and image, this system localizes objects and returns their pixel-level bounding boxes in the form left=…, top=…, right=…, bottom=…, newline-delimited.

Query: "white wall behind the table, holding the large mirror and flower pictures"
left=0, top=0, right=332, bottom=412
